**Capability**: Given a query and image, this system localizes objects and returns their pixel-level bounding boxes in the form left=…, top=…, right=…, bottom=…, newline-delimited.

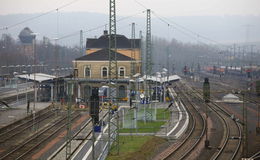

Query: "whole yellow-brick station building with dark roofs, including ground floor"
left=70, top=30, right=142, bottom=99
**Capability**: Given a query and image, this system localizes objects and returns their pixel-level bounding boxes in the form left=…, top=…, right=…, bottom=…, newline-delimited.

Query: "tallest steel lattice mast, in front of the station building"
left=108, top=0, right=119, bottom=154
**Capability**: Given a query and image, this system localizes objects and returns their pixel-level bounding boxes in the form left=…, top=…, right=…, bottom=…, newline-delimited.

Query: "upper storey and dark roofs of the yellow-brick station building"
left=73, top=31, right=141, bottom=79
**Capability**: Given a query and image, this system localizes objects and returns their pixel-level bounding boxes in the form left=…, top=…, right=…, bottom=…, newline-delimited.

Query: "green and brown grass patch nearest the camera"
left=106, top=136, right=166, bottom=160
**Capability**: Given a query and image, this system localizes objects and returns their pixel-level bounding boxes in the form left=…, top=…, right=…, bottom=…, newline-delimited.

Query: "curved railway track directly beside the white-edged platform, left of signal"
left=155, top=85, right=206, bottom=160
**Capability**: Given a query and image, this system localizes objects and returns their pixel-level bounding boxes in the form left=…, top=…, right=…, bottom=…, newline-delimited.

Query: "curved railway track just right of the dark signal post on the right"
left=182, top=82, right=242, bottom=160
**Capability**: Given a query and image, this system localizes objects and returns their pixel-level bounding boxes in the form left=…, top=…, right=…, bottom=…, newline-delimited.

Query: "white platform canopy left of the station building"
left=16, top=73, right=56, bottom=82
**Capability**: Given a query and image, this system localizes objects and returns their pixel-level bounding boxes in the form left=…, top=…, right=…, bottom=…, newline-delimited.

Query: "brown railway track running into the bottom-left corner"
left=0, top=112, right=80, bottom=160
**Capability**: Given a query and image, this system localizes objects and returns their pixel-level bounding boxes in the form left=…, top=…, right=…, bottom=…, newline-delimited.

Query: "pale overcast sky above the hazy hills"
left=0, top=0, right=260, bottom=16
